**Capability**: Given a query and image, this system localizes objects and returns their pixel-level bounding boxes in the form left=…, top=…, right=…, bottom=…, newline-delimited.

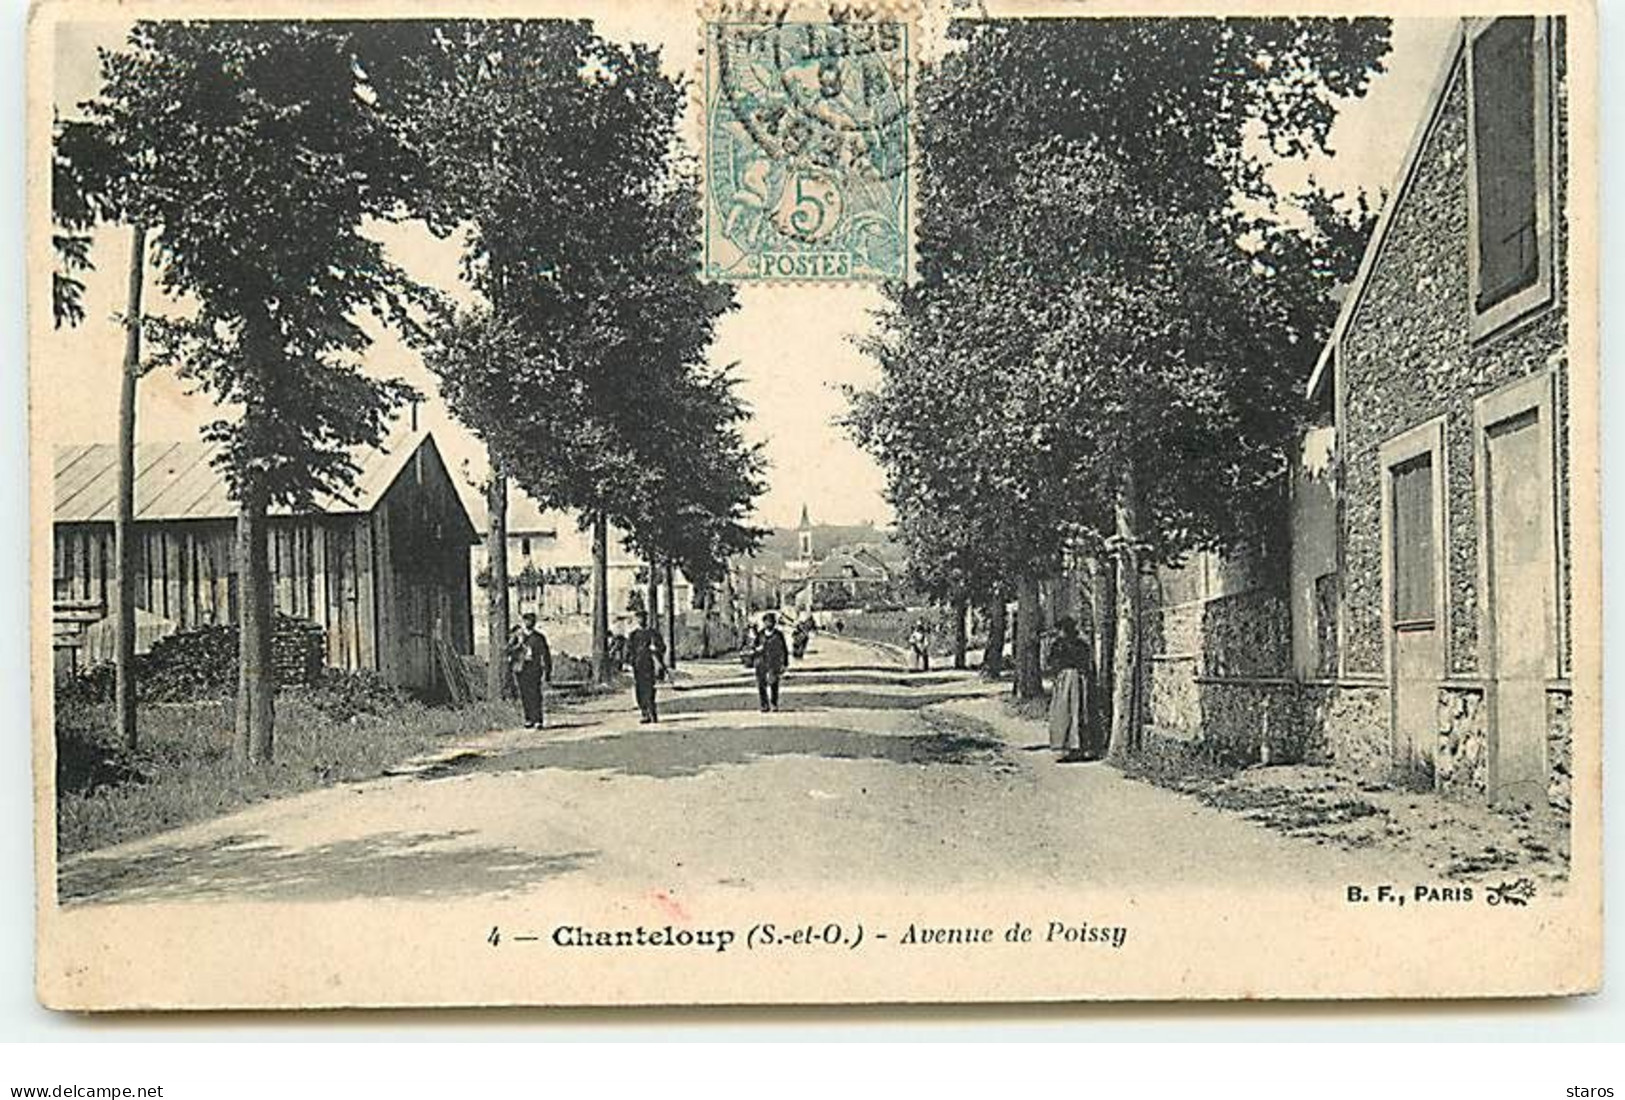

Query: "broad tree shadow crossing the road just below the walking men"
left=418, top=725, right=1003, bottom=780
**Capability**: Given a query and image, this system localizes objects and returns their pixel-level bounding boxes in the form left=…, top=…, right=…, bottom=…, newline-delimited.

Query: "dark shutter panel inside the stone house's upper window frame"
left=1472, top=16, right=1541, bottom=312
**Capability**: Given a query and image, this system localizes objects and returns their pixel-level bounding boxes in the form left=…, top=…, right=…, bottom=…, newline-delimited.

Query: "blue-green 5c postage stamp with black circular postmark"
left=704, top=16, right=910, bottom=281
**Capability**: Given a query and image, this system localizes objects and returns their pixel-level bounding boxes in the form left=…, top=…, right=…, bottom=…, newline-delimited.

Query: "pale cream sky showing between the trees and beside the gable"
left=36, top=16, right=1453, bottom=526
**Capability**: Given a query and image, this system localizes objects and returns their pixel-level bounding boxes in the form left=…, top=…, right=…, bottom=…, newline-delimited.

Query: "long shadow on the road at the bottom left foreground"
left=57, top=830, right=598, bottom=905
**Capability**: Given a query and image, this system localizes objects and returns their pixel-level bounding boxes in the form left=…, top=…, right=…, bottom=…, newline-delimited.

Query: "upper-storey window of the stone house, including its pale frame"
left=1467, top=16, right=1552, bottom=335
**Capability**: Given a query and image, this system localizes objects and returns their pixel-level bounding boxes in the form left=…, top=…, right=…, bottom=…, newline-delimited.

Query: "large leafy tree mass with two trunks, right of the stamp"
left=868, top=19, right=1388, bottom=721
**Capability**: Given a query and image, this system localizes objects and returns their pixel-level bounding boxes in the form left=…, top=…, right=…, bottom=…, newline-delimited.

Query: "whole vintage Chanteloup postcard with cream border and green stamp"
left=28, top=0, right=1602, bottom=1011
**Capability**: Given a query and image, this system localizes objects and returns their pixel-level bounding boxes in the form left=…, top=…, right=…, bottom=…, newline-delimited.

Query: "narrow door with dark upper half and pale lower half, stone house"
left=1388, top=452, right=1445, bottom=785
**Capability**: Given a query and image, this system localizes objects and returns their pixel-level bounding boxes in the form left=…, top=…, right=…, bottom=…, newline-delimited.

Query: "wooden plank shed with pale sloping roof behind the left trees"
left=52, top=431, right=478, bottom=694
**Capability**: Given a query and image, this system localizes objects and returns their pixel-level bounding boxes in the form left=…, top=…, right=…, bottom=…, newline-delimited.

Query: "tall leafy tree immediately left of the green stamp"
left=403, top=21, right=733, bottom=678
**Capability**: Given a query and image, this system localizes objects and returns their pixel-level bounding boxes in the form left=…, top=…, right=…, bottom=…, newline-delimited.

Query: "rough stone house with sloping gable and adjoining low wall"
left=1147, top=16, right=1573, bottom=812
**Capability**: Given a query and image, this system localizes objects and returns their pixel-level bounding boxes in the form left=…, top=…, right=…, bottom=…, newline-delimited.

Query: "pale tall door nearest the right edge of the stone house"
left=1484, top=409, right=1554, bottom=806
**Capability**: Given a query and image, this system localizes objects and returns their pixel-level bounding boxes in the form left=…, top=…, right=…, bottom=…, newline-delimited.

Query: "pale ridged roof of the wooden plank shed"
left=54, top=429, right=432, bottom=523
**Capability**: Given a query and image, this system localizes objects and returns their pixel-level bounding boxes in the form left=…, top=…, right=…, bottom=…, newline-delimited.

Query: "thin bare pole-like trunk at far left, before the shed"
left=112, top=223, right=146, bottom=749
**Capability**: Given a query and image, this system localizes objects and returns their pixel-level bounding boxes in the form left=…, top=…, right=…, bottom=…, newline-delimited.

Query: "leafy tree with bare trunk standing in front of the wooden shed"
left=86, top=21, right=432, bottom=760
